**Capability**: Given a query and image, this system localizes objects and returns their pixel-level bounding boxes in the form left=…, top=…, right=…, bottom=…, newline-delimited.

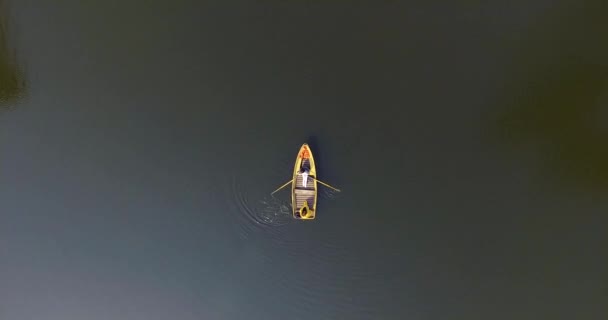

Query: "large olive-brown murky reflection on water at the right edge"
left=500, top=2, right=608, bottom=190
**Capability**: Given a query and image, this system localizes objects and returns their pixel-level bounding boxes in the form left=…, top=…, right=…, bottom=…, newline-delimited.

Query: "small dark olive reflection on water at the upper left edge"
left=0, top=0, right=27, bottom=106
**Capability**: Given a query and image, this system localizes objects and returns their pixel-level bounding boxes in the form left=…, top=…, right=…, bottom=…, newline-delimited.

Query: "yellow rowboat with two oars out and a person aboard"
left=271, top=143, right=340, bottom=220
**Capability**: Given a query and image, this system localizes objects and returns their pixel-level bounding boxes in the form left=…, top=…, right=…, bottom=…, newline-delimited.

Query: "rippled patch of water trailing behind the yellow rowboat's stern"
left=218, top=150, right=384, bottom=319
